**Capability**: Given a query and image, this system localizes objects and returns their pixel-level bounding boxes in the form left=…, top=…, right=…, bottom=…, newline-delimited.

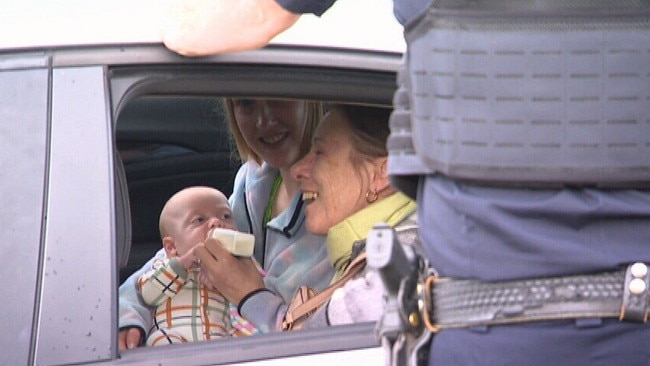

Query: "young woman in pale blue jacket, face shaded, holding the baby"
left=118, top=99, right=333, bottom=350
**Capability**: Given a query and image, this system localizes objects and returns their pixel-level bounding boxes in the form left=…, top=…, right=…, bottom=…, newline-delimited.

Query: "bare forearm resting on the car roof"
left=161, top=0, right=300, bottom=56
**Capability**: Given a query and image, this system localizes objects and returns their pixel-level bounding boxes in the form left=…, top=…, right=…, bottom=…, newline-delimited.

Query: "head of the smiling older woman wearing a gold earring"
left=291, top=105, right=396, bottom=235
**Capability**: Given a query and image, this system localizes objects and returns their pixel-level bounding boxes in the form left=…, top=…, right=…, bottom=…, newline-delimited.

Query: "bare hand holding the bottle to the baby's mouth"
left=194, top=239, right=265, bottom=304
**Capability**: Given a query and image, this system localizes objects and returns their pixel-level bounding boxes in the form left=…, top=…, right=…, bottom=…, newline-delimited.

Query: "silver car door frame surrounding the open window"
left=13, top=45, right=400, bottom=365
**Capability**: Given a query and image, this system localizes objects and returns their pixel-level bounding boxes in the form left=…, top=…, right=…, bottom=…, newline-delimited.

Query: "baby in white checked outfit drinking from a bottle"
left=138, top=187, right=257, bottom=346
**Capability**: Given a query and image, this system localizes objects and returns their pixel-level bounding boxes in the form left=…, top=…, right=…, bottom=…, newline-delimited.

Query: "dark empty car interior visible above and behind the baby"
left=116, top=96, right=239, bottom=283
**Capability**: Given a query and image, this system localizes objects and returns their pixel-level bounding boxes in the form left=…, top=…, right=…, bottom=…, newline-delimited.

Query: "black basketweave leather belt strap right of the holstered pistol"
left=421, top=262, right=650, bottom=332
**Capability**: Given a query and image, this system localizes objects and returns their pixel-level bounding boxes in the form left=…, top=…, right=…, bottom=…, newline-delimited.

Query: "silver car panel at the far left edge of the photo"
left=0, top=54, right=49, bottom=365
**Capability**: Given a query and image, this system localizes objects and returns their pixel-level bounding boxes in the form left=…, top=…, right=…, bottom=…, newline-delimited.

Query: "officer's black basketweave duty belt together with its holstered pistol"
left=366, top=224, right=650, bottom=365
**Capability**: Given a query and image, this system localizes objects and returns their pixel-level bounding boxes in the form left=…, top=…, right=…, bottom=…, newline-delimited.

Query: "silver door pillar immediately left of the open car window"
left=34, top=65, right=118, bottom=365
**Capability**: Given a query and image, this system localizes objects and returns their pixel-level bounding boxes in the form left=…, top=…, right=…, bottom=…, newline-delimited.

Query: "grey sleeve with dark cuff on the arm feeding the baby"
left=239, top=291, right=287, bottom=333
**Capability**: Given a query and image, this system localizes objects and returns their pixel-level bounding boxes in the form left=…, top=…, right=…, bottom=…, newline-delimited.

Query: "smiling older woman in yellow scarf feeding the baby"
left=196, top=105, right=417, bottom=332
